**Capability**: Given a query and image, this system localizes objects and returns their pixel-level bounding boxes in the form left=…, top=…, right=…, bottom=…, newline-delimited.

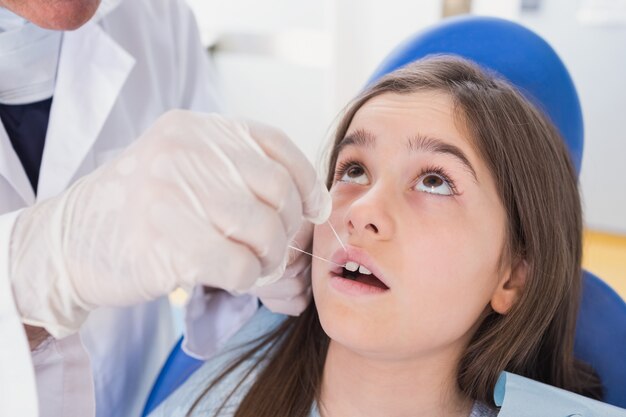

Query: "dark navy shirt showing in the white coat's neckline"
left=0, top=98, right=52, bottom=194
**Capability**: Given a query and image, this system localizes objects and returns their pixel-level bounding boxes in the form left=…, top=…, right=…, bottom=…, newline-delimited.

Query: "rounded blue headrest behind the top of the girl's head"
left=368, top=16, right=584, bottom=173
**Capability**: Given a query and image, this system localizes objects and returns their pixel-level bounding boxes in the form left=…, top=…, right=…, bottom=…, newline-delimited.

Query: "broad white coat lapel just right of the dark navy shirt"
left=37, top=23, right=135, bottom=200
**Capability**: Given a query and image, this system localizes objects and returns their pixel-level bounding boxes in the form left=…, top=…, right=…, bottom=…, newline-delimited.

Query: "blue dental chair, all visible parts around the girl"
left=143, top=16, right=626, bottom=415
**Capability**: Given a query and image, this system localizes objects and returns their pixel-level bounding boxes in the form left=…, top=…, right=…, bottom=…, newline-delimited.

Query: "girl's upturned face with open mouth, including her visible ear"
left=312, top=92, right=511, bottom=360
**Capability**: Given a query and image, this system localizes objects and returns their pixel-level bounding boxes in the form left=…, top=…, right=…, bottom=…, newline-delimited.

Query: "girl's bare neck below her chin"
left=319, top=341, right=473, bottom=417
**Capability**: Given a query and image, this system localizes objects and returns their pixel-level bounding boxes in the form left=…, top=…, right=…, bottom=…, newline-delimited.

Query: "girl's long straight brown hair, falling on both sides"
left=186, top=56, right=602, bottom=417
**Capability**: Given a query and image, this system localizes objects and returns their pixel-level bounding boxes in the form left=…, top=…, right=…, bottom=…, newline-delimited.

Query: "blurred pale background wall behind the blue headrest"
left=177, top=0, right=626, bottom=296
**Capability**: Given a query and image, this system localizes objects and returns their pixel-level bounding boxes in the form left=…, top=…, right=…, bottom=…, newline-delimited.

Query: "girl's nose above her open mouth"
left=345, top=187, right=395, bottom=241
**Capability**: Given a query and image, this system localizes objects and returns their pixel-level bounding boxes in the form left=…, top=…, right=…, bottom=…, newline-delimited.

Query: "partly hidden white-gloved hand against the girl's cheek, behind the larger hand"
left=249, top=223, right=313, bottom=316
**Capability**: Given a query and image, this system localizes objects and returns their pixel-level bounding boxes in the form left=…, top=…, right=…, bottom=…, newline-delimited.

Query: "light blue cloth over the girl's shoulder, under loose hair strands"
left=150, top=307, right=287, bottom=417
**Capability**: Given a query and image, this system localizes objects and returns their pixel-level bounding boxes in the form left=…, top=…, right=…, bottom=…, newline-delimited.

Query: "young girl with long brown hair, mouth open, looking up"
left=154, top=57, right=601, bottom=417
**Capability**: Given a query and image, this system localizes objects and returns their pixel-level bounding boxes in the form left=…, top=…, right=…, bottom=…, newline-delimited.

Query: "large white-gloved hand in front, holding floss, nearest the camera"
left=10, top=110, right=331, bottom=337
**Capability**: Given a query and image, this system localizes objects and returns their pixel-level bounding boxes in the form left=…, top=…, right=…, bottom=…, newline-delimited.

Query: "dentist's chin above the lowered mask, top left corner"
left=14, top=0, right=100, bottom=30
